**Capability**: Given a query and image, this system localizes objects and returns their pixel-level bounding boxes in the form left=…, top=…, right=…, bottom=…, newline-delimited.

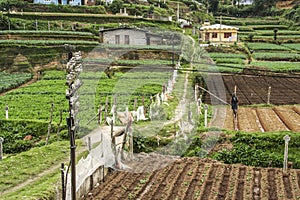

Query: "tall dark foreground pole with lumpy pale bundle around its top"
left=66, top=46, right=83, bottom=200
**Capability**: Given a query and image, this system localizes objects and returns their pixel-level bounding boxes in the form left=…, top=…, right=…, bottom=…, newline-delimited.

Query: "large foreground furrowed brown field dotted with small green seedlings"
left=83, top=157, right=300, bottom=200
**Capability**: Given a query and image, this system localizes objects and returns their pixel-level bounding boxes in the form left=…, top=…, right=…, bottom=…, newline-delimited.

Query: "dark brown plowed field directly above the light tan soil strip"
left=203, top=74, right=300, bottom=105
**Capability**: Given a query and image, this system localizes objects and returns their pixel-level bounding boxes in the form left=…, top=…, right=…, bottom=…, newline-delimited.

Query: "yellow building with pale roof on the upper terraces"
left=200, top=23, right=239, bottom=43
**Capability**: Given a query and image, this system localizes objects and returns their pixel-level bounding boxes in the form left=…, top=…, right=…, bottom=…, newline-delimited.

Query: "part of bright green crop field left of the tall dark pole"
left=0, top=71, right=68, bottom=124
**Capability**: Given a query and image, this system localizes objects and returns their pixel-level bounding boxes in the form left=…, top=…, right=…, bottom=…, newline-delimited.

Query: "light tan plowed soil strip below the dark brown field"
left=220, top=106, right=300, bottom=132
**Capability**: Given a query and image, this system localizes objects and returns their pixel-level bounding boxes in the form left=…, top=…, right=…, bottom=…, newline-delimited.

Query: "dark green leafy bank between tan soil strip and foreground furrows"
left=213, top=132, right=300, bottom=169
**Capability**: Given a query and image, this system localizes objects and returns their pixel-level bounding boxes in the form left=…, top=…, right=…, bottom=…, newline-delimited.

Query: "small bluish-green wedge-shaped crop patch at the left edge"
left=0, top=72, right=32, bottom=92
